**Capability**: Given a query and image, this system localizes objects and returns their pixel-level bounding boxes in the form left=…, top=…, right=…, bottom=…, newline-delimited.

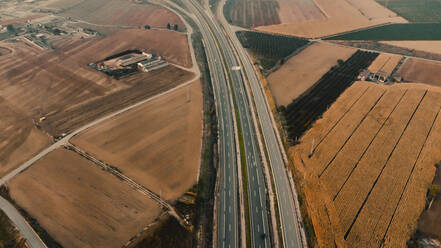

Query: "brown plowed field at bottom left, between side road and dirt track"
left=8, top=149, right=161, bottom=248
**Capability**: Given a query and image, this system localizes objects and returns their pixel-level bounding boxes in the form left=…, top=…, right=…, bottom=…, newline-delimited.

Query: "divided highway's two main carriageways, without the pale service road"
left=177, top=0, right=271, bottom=247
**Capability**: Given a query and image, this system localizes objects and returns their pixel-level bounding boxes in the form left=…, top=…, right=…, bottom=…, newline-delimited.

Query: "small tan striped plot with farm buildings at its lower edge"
left=367, top=53, right=403, bottom=83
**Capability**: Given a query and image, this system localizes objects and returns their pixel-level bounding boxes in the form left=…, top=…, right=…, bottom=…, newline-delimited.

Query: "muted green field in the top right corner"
left=376, top=0, right=441, bottom=22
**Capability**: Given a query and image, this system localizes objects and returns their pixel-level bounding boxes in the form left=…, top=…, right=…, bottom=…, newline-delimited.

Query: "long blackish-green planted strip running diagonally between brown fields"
left=282, top=50, right=378, bottom=143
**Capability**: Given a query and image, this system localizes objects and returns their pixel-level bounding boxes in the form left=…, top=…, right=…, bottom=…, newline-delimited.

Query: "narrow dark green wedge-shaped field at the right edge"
left=326, top=23, right=441, bottom=40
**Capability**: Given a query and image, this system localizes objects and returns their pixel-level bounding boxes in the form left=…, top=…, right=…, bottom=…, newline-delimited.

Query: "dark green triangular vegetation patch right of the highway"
left=236, top=31, right=309, bottom=70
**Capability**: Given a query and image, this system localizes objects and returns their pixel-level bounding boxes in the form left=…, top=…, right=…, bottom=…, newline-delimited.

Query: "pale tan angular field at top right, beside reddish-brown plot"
left=256, top=0, right=407, bottom=38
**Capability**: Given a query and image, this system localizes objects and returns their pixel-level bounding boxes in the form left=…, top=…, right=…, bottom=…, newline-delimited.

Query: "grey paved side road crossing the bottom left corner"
left=0, top=197, right=47, bottom=248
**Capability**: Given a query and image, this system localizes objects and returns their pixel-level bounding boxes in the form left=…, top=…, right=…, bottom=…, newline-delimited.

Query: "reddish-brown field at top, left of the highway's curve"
left=49, top=0, right=184, bottom=27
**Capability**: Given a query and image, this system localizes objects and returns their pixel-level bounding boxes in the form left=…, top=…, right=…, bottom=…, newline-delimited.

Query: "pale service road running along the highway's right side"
left=220, top=6, right=306, bottom=248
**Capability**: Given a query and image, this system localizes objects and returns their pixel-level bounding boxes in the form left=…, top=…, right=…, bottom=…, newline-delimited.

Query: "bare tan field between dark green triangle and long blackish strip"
left=268, top=43, right=356, bottom=106
